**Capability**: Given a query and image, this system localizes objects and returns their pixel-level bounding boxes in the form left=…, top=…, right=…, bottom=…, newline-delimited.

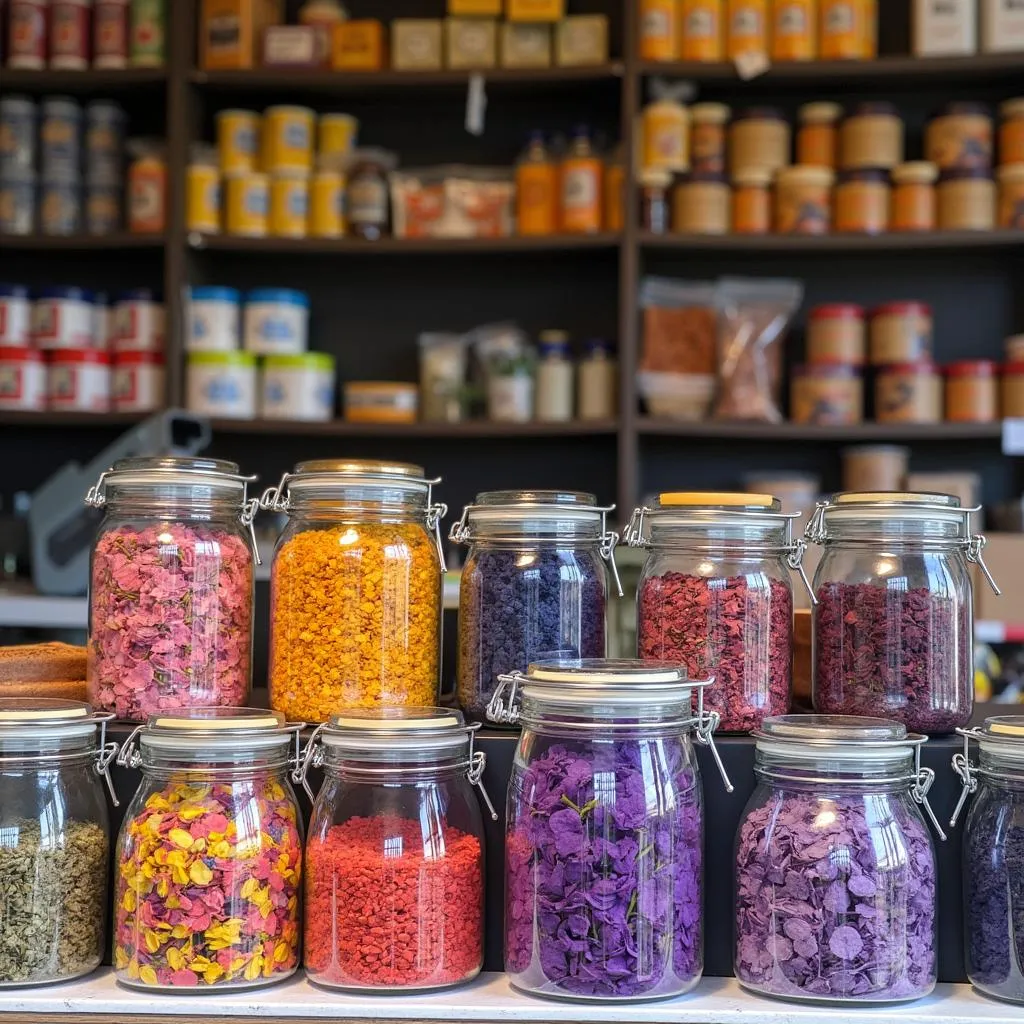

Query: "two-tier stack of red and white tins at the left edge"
left=0, top=285, right=164, bottom=413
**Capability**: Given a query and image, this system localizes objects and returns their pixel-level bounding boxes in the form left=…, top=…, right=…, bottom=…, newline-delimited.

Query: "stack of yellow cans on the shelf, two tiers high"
left=186, top=105, right=358, bottom=239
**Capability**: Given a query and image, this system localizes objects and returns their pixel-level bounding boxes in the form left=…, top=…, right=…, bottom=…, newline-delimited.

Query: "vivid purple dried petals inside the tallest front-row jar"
left=505, top=739, right=703, bottom=998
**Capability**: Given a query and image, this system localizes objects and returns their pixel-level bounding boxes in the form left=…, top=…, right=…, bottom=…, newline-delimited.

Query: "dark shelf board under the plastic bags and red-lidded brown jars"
left=638, top=417, right=1002, bottom=443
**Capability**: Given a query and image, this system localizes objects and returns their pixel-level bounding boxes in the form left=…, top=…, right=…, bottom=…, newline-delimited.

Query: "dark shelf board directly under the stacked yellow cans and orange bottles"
left=188, top=231, right=622, bottom=256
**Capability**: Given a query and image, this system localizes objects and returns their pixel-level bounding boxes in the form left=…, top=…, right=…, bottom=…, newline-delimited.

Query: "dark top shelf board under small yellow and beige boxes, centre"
left=190, top=61, right=624, bottom=94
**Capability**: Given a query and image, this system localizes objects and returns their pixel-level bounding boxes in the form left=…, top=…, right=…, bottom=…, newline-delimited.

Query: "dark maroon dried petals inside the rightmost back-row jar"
left=813, top=578, right=974, bottom=734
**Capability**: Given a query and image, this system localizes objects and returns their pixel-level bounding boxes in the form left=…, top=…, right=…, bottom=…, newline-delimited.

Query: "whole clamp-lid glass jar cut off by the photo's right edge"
left=950, top=715, right=1024, bottom=1004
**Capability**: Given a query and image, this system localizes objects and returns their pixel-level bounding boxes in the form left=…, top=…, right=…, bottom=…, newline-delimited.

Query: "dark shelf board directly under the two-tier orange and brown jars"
left=639, top=230, right=1024, bottom=252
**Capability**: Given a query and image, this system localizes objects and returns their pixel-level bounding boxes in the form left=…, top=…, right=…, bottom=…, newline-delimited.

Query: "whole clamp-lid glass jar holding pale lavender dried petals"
left=735, top=715, right=945, bottom=1004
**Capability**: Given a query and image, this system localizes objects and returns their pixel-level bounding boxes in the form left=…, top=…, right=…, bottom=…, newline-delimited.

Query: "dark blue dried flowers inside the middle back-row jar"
left=457, top=546, right=606, bottom=720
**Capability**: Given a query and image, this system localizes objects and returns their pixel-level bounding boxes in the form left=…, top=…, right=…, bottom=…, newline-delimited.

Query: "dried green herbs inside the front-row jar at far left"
left=0, top=820, right=109, bottom=984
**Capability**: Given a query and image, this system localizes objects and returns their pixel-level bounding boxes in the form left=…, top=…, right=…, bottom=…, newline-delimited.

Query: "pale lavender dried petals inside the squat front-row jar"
left=735, top=790, right=936, bottom=1000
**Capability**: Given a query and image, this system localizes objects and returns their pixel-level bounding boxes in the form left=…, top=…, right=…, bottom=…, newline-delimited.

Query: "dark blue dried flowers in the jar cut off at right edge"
left=964, top=786, right=1024, bottom=1000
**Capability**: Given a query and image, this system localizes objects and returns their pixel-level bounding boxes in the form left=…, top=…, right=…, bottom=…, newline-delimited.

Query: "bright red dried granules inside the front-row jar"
left=305, top=815, right=483, bottom=988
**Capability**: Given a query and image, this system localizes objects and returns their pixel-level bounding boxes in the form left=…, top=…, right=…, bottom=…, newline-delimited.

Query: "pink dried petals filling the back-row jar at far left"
left=88, top=522, right=253, bottom=722
